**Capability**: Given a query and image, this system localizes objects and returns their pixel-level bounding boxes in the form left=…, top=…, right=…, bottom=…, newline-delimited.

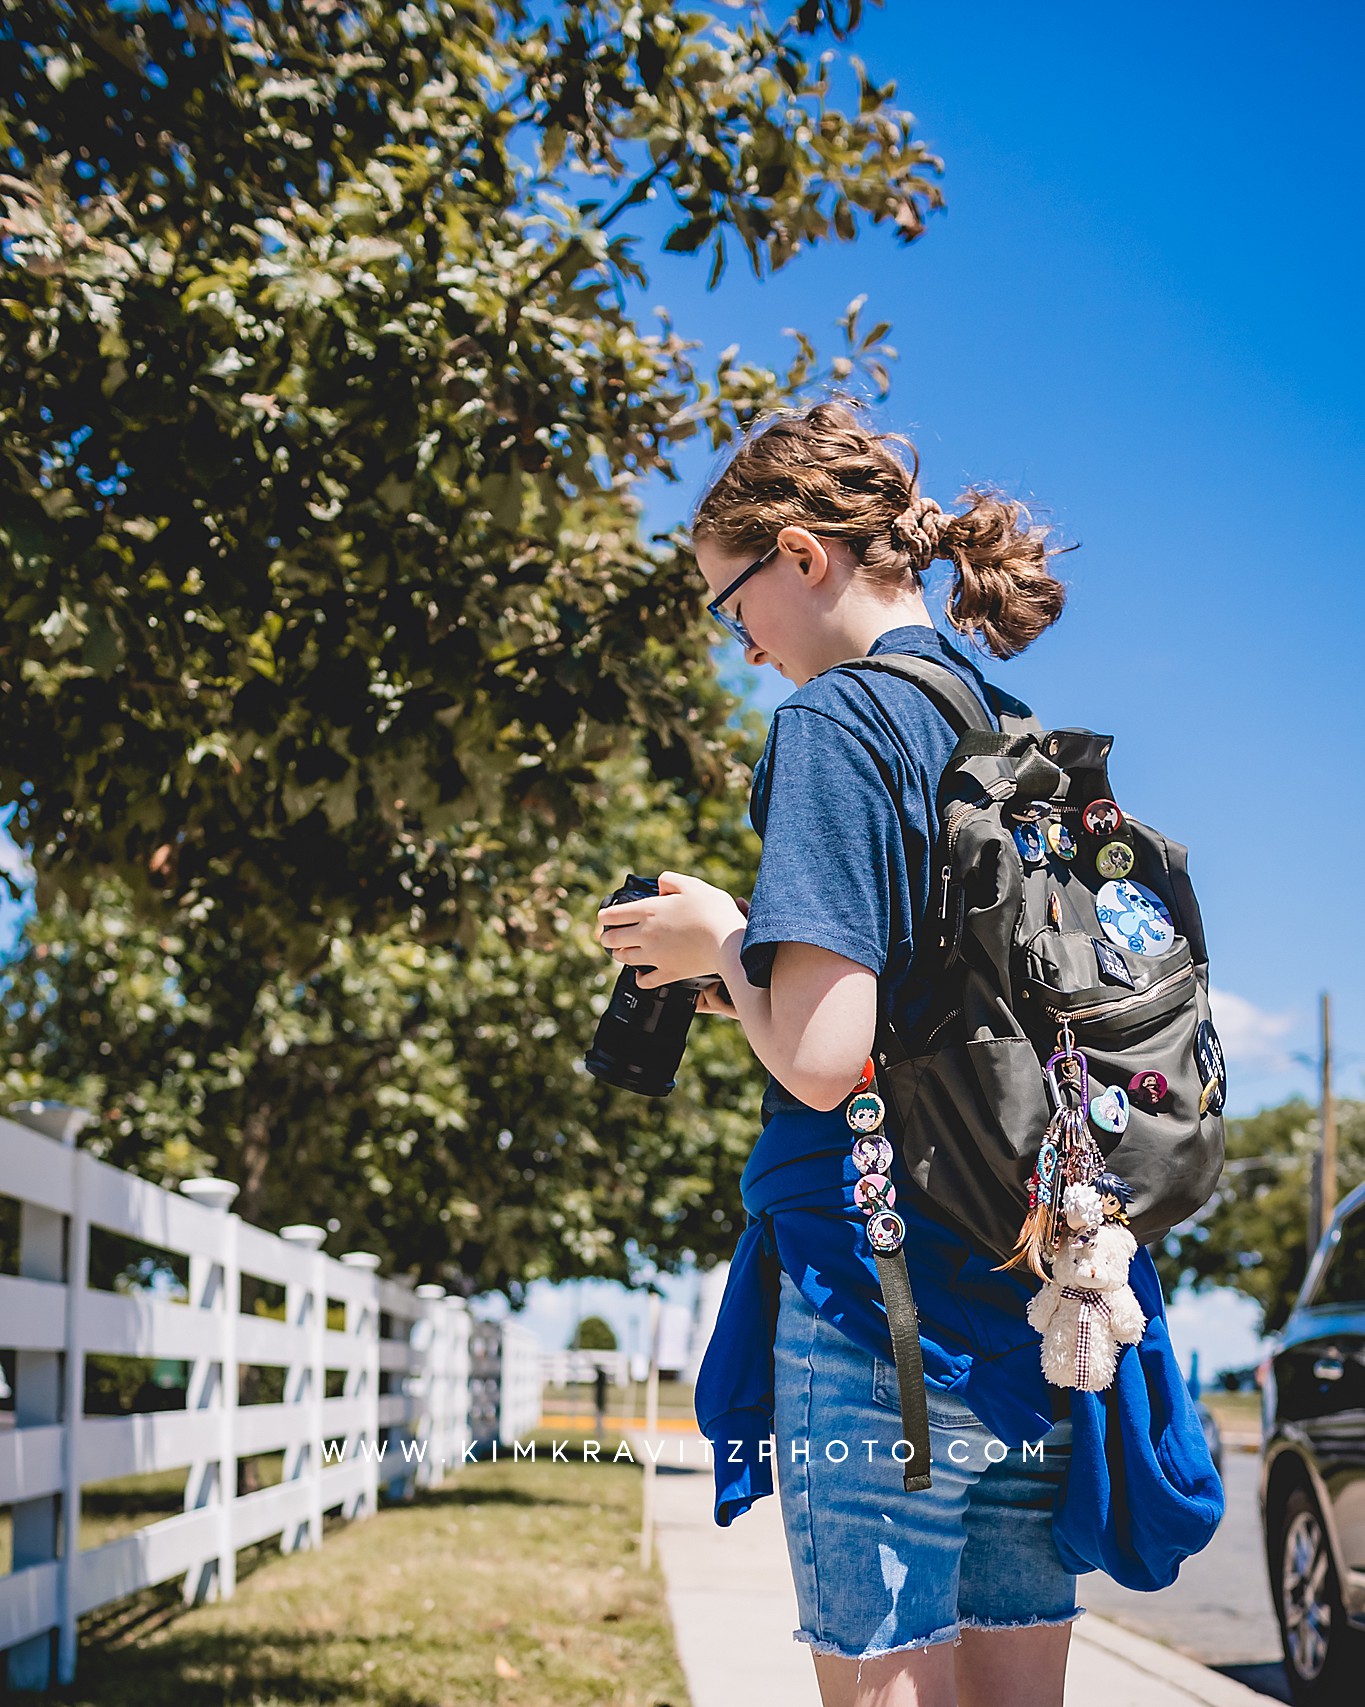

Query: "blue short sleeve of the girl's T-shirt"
left=741, top=707, right=906, bottom=985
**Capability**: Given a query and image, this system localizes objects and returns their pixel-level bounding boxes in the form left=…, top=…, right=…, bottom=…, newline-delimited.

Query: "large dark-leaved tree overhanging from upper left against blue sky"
left=0, top=0, right=937, bottom=970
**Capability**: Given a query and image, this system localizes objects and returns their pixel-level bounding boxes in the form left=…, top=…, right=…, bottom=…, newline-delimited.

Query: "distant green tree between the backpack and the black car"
left=1153, top=1098, right=1365, bottom=1333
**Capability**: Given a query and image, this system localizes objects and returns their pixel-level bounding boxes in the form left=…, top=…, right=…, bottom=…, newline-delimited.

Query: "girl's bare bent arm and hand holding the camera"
left=597, top=871, right=877, bottom=1108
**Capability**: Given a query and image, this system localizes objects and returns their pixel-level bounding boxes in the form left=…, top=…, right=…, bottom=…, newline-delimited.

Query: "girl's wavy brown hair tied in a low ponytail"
left=691, top=398, right=1066, bottom=657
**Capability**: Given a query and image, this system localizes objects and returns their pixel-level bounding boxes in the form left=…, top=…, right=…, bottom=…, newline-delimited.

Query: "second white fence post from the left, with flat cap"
left=181, top=1176, right=241, bottom=1605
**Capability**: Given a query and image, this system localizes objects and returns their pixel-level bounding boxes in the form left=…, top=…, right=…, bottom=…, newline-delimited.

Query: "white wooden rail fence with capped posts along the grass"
left=0, top=1104, right=541, bottom=1690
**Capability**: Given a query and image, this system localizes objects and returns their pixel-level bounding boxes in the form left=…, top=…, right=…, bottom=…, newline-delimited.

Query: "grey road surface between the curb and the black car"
left=1077, top=1448, right=1290, bottom=1702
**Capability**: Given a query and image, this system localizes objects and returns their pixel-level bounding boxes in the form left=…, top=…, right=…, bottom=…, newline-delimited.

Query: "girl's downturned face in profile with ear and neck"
left=694, top=527, right=848, bottom=686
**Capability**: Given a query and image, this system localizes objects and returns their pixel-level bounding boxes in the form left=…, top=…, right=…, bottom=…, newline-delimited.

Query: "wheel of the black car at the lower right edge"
left=1271, top=1487, right=1365, bottom=1707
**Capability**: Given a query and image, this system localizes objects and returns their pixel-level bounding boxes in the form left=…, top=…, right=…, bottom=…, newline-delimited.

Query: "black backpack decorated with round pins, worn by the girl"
left=836, top=652, right=1227, bottom=1487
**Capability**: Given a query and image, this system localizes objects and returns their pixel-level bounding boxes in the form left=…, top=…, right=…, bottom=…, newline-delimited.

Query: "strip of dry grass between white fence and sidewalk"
left=46, top=1442, right=688, bottom=1707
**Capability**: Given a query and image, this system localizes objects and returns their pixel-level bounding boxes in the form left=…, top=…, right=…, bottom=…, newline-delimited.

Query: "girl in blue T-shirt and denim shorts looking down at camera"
left=599, top=401, right=1105, bottom=1707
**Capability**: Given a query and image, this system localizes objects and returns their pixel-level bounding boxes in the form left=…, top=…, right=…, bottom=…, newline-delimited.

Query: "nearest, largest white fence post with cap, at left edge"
left=5, top=1101, right=96, bottom=1690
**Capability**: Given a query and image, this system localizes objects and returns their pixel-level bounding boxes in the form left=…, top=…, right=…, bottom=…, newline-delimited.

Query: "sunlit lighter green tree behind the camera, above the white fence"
left=0, top=761, right=759, bottom=1292
